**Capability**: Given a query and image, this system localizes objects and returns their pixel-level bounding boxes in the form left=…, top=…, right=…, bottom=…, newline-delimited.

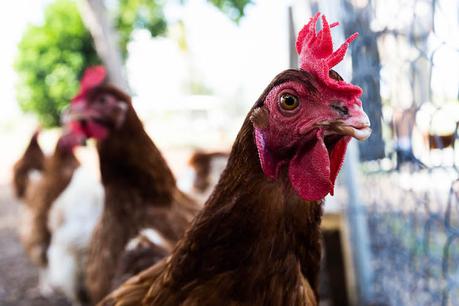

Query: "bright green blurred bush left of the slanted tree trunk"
left=16, top=0, right=100, bottom=127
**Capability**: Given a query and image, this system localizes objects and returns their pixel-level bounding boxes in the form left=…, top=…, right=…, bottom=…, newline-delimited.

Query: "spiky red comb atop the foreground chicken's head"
left=296, top=13, right=362, bottom=96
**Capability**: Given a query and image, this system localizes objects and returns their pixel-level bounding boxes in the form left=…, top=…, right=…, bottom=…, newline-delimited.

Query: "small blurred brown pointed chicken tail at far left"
left=13, top=129, right=45, bottom=200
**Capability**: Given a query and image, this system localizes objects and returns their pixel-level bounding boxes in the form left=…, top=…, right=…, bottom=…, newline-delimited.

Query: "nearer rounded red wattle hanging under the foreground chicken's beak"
left=288, top=130, right=333, bottom=201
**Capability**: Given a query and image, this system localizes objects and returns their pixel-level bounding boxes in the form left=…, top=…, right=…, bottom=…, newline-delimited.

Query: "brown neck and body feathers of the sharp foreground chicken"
left=100, top=71, right=322, bottom=306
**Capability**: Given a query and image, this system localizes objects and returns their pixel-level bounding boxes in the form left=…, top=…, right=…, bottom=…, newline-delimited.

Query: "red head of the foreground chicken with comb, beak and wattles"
left=251, top=14, right=371, bottom=201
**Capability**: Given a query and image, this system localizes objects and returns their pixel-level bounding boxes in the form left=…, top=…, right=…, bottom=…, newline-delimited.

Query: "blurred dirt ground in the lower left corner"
left=0, top=185, right=69, bottom=306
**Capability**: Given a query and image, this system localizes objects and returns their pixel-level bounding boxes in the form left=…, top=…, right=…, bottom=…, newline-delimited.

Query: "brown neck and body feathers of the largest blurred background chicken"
left=86, top=88, right=199, bottom=302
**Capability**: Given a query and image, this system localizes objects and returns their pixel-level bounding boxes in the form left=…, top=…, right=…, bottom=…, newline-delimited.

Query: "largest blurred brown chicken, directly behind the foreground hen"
left=63, top=66, right=200, bottom=303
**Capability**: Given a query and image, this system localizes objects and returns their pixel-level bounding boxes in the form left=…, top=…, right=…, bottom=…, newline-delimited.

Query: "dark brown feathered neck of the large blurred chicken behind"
left=97, top=103, right=176, bottom=205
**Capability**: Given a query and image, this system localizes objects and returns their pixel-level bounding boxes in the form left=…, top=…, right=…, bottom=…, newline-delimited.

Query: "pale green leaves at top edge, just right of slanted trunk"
left=115, top=0, right=167, bottom=58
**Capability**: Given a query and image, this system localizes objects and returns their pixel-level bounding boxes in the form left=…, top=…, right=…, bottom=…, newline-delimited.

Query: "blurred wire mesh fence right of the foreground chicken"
left=330, top=0, right=459, bottom=306
